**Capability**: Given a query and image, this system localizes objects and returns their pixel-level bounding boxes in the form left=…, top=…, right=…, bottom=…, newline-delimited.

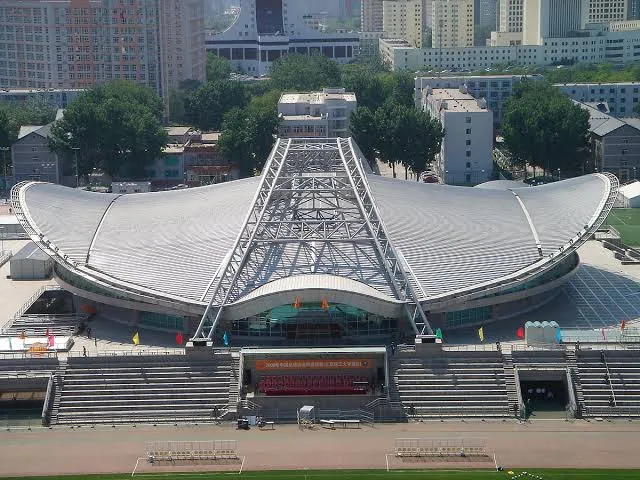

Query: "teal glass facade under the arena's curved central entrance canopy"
left=232, top=303, right=397, bottom=340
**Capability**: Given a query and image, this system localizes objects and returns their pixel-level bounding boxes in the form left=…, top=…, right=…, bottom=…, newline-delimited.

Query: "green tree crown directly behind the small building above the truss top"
left=270, top=54, right=340, bottom=91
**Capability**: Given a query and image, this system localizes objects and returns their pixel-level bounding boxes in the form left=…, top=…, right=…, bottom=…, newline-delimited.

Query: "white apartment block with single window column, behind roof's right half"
left=422, top=87, right=493, bottom=185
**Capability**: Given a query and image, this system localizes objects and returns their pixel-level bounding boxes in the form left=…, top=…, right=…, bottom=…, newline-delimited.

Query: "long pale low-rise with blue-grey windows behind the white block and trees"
left=414, top=75, right=543, bottom=126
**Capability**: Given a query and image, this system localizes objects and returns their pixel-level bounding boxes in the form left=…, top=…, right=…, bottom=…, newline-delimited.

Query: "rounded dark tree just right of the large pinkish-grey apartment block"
left=185, top=80, right=247, bottom=131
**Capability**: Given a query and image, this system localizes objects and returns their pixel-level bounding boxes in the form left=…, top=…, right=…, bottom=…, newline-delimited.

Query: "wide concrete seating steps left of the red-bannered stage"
left=51, top=353, right=231, bottom=425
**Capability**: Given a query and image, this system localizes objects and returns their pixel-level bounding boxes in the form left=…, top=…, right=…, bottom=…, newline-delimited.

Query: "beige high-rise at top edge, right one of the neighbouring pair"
left=431, top=0, right=474, bottom=48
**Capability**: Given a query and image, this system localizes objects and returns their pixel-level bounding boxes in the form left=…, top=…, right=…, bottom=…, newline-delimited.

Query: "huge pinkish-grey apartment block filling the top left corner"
left=0, top=0, right=205, bottom=98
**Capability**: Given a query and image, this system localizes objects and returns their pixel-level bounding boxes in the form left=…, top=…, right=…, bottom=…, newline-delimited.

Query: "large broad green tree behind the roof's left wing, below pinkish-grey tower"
left=50, top=81, right=167, bottom=178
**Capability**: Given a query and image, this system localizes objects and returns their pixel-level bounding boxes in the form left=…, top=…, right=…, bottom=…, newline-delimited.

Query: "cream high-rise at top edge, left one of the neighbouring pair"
left=382, top=0, right=422, bottom=48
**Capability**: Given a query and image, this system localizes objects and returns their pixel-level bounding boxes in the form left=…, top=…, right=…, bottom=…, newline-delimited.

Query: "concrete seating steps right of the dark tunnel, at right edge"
left=576, top=350, right=640, bottom=417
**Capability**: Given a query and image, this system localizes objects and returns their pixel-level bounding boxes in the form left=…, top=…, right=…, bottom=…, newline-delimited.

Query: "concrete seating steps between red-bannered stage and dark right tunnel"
left=391, top=351, right=511, bottom=418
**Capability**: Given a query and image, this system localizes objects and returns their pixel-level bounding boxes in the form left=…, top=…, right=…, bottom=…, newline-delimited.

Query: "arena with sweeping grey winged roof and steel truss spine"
left=11, top=139, right=618, bottom=342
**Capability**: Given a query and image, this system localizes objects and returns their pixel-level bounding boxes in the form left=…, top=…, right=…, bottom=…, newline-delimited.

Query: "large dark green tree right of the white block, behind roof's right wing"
left=502, top=80, right=590, bottom=173
